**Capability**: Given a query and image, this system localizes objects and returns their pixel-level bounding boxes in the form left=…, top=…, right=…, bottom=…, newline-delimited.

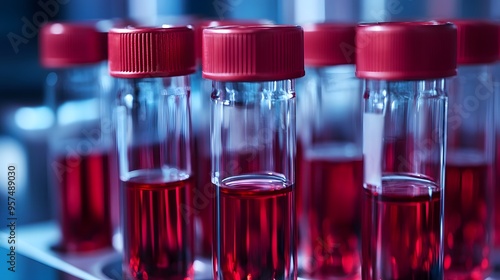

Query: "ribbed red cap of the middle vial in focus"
left=202, top=25, right=304, bottom=82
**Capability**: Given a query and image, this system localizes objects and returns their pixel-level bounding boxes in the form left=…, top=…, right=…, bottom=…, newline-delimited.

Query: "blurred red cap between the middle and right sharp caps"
left=303, top=23, right=356, bottom=67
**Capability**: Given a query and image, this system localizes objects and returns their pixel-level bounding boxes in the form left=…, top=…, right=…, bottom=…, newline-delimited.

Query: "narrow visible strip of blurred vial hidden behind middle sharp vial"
left=191, top=17, right=271, bottom=263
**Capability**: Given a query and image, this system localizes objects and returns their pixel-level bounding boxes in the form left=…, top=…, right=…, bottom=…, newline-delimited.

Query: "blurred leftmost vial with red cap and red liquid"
left=40, top=23, right=113, bottom=252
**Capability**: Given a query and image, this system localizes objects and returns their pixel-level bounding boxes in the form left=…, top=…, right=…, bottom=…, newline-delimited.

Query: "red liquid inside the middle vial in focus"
left=214, top=175, right=297, bottom=280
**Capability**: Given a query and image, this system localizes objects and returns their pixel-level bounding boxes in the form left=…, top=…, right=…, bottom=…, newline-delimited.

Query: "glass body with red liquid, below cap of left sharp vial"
left=116, top=76, right=194, bottom=279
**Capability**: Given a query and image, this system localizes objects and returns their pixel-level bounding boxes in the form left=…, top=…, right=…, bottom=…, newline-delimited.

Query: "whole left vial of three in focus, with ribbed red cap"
left=108, top=27, right=195, bottom=280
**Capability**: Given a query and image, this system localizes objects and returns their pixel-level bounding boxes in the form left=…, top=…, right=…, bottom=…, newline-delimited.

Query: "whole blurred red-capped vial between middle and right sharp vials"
left=296, top=23, right=363, bottom=279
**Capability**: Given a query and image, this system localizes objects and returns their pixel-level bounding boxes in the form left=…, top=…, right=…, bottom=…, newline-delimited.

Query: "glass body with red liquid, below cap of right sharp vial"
left=362, top=79, right=447, bottom=279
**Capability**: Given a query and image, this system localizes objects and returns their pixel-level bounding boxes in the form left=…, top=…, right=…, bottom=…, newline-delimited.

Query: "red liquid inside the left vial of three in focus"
left=122, top=172, right=194, bottom=280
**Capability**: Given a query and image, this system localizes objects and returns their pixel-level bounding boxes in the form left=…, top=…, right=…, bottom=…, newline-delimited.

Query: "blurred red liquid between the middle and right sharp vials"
left=300, top=151, right=363, bottom=278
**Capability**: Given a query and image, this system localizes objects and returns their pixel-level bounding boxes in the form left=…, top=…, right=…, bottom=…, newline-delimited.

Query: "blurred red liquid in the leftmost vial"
left=52, top=153, right=112, bottom=252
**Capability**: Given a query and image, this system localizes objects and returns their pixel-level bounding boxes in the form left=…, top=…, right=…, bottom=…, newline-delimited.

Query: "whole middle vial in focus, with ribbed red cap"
left=202, top=25, right=304, bottom=279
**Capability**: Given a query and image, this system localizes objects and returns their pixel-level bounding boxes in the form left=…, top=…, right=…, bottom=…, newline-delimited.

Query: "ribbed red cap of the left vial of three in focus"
left=108, top=26, right=195, bottom=78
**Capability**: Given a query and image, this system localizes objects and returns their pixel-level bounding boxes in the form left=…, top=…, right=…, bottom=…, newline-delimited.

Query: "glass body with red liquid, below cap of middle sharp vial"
left=212, top=80, right=296, bottom=279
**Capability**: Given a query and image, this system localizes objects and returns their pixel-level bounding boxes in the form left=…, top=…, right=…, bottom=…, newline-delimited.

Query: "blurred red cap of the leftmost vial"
left=39, top=22, right=107, bottom=68
